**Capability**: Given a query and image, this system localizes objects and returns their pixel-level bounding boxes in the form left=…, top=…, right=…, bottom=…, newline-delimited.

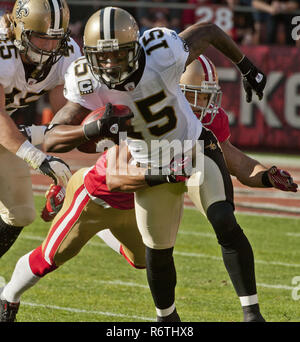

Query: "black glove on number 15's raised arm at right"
left=236, top=56, right=267, bottom=102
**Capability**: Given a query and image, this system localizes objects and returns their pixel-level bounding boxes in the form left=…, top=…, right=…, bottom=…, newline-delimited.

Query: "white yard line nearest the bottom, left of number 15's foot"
left=21, top=302, right=156, bottom=322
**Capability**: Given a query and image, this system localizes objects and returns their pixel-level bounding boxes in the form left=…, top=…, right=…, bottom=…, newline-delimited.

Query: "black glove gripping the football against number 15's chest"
left=83, top=103, right=134, bottom=144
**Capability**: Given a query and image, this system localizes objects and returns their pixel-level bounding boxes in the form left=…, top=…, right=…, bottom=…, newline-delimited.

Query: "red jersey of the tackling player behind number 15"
left=84, top=108, right=230, bottom=210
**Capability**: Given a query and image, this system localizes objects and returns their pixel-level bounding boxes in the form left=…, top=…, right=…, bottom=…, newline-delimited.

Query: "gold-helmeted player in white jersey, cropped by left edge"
left=0, top=0, right=81, bottom=257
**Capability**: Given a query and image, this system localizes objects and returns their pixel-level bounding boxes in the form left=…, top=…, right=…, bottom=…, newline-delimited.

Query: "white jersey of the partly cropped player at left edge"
left=0, top=39, right=81, bottom=115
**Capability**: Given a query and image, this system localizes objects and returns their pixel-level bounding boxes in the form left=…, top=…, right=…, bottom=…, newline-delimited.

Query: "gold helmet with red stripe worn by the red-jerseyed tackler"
left=180, top=55, right=222, bottom=125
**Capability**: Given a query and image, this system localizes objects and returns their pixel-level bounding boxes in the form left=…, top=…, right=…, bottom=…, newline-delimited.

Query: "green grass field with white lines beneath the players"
left=0, top=197, right=300, bottom=322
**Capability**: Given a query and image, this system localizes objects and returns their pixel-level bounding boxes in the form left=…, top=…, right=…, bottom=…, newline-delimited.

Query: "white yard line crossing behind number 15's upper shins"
left=20, top=235, right=300, bottom=267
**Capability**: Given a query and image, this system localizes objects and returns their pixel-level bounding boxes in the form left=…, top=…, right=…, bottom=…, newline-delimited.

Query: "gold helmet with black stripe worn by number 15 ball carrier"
left=83, top=7, right=141, bottom=88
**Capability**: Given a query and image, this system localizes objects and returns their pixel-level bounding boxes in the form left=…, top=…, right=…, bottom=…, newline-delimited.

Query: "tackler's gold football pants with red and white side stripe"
left=37, top=169, right=145, bottom=270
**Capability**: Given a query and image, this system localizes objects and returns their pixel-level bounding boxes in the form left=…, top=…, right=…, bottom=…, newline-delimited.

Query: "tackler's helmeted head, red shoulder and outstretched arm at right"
left=180, top=55, right=298, bottom=195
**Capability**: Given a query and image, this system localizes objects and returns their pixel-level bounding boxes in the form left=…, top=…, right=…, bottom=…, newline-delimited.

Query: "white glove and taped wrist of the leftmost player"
left=16, top=140, right=72, bottom=186
